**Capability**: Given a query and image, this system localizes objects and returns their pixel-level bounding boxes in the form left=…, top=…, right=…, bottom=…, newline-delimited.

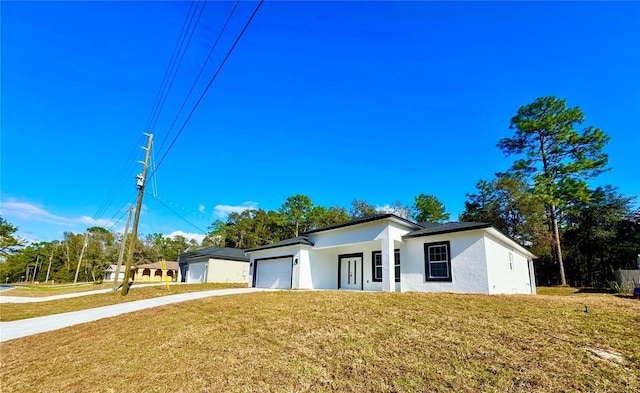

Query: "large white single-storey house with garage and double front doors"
left=247, top=214, right=536, bottom=294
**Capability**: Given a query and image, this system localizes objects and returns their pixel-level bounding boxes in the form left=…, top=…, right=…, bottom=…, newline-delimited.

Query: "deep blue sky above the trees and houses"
left=0, top=1, right=640, bottom=241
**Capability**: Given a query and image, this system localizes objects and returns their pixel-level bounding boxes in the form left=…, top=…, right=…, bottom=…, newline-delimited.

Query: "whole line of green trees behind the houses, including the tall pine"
left=0, top=97, right=640, bottom=287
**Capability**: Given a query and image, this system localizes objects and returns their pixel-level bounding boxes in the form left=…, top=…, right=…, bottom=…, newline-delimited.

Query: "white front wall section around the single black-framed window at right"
left=400, top=231, right=489, bottom=293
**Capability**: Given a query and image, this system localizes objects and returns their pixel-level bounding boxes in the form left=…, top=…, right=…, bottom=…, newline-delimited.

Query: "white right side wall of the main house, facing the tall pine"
left=484, top=234, right=535, bottom=294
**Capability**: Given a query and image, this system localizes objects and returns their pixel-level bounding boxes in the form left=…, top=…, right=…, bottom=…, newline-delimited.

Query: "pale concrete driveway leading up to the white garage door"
left=0, top=288, right=272, bottom=342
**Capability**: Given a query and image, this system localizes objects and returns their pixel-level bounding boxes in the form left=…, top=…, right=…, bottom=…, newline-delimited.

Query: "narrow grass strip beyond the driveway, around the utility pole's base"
left=0, top=283, right=247, bottom=322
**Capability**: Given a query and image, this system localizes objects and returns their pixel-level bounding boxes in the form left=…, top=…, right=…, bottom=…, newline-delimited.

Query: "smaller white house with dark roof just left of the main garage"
left=178, top=247, right=249, bottom=283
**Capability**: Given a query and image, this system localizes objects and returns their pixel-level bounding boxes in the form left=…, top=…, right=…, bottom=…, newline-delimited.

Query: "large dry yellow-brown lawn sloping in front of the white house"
left=0, top=291, right=640, bottom=392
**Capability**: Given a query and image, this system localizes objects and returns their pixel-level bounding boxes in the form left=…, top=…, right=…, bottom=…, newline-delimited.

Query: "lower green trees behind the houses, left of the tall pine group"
left=0, top=194, right=449, bottom=282
